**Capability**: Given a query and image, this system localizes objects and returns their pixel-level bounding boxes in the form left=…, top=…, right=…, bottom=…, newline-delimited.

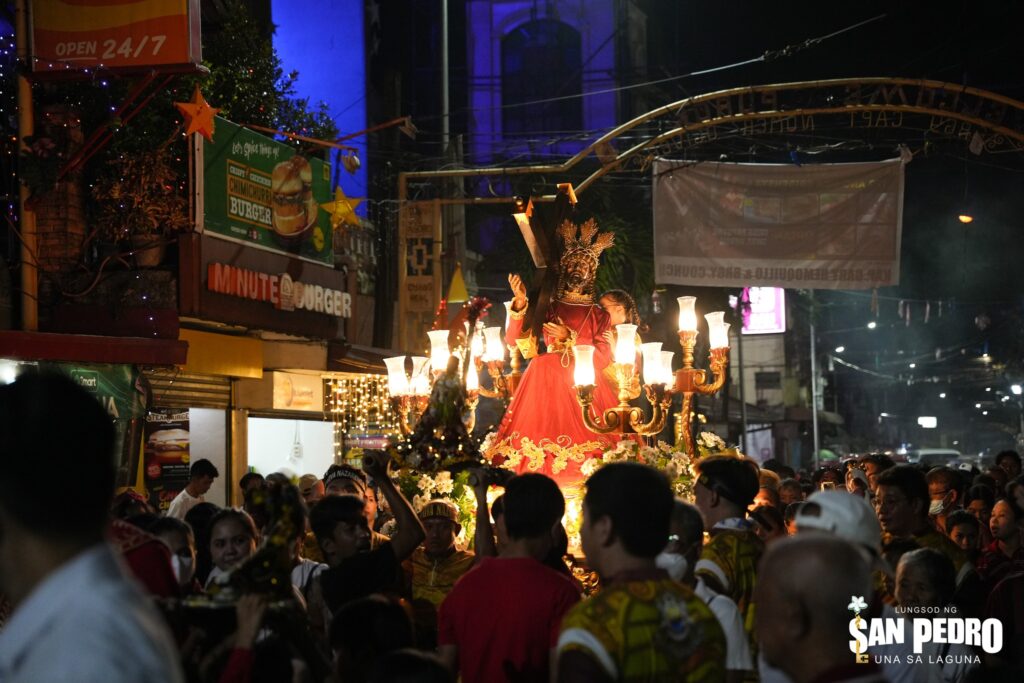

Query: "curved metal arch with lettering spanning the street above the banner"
left=399, top=78, right=1024, bottom=203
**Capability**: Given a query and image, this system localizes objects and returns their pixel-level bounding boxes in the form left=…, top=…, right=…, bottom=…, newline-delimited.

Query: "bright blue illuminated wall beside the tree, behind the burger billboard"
left=270, top=0, right=368, bottom=216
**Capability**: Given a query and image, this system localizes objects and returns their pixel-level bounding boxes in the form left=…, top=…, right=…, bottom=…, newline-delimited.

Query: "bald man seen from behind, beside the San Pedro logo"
left=755, top=535, right=886, bottom=683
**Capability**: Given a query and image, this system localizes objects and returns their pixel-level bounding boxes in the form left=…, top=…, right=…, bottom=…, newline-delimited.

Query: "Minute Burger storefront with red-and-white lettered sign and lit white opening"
left=180, top=229, right=351, bottom=505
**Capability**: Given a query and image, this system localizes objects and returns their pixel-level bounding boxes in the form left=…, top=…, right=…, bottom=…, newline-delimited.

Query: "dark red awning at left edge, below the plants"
left=0, top=330, right=188, bottom=366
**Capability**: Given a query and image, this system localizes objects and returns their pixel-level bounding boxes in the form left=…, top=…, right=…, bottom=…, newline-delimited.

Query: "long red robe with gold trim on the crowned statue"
left=484, top=300, right=621, bottom=486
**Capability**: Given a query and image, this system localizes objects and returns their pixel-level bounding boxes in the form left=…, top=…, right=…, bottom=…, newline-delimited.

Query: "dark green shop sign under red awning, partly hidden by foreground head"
left=39, top=362, right=145, bottom=487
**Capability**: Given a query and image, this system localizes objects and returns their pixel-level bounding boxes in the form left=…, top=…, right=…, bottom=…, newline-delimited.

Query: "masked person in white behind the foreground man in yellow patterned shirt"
left=654, top=499, right=754, bottom=683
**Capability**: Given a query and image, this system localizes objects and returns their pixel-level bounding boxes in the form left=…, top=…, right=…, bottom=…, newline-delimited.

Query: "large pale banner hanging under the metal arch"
left=653, top=159, right=904, bottom=290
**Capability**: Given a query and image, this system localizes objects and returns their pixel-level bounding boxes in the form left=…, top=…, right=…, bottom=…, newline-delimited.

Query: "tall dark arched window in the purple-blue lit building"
left=502, top=19, right=583, bottom=137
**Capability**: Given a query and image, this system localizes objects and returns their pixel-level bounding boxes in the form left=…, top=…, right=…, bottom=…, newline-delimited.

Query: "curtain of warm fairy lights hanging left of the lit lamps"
left=327, top=374, right=398, bottom=459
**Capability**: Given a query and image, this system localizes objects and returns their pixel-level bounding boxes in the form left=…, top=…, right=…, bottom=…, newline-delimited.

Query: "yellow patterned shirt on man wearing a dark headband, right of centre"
left=694, top=518, right=764, bottom=653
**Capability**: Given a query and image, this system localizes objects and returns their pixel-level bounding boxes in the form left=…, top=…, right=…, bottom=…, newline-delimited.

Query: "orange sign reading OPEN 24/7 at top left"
left=32, top=0, right=202, bottom=72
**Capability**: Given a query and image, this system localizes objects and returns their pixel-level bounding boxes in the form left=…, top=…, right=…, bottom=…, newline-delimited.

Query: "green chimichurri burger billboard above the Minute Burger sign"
left=203, top=117, right=334, bottom=266
